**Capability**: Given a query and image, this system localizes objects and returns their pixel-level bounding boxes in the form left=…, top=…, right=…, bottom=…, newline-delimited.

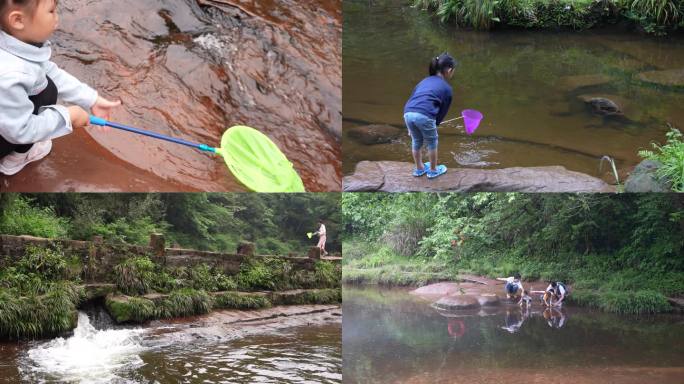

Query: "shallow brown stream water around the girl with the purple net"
left=343, top=0, right=684, bottom=182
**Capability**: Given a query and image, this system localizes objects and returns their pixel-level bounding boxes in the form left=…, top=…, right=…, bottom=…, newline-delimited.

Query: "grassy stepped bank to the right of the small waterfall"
left=101, top=257, right=341, bottom=323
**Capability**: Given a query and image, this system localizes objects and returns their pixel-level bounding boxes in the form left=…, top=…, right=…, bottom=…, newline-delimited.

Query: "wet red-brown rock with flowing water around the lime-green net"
left=0, top=0, right=342, bottom=191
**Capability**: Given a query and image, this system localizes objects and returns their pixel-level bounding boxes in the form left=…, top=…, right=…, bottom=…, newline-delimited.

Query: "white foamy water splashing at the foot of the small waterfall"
left=22, top=312, right=144, bottom=384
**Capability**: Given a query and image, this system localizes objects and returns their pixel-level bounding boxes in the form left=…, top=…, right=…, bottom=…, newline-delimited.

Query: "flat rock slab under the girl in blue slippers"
left=343, top=161, right=615, bottom=193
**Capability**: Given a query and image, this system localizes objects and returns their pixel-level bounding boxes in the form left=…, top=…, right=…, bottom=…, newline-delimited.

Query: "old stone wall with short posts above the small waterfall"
left=0, top=234, right=332, bottom=282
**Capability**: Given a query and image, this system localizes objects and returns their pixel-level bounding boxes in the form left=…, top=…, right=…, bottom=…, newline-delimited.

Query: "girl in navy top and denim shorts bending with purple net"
left=404, top=53, right=456, bottom=179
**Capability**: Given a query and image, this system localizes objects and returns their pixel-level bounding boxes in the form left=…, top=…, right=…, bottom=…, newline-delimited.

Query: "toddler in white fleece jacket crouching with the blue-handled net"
left=0, top=0, right=121, bottom=175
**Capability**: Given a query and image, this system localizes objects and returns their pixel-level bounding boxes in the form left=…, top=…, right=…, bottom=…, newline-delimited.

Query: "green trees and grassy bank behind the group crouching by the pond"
left=342, top=193, right=684, bottom=313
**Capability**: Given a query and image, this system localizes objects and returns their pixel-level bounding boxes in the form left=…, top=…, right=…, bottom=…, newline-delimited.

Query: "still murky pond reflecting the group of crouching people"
left=343, top=286, right=684, bottom=384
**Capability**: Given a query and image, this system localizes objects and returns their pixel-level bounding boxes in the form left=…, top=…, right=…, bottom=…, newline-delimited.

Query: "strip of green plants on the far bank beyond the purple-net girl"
left=412, top=0, right=684, bottom=35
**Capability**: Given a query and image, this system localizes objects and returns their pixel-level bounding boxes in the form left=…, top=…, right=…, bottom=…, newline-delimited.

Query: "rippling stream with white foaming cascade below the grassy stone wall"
left=0, top=306, right=342, bottom=384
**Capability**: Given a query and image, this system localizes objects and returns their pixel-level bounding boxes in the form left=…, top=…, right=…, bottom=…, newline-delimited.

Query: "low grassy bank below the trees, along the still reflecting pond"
left=342, top=239, right=684, bottom=314
